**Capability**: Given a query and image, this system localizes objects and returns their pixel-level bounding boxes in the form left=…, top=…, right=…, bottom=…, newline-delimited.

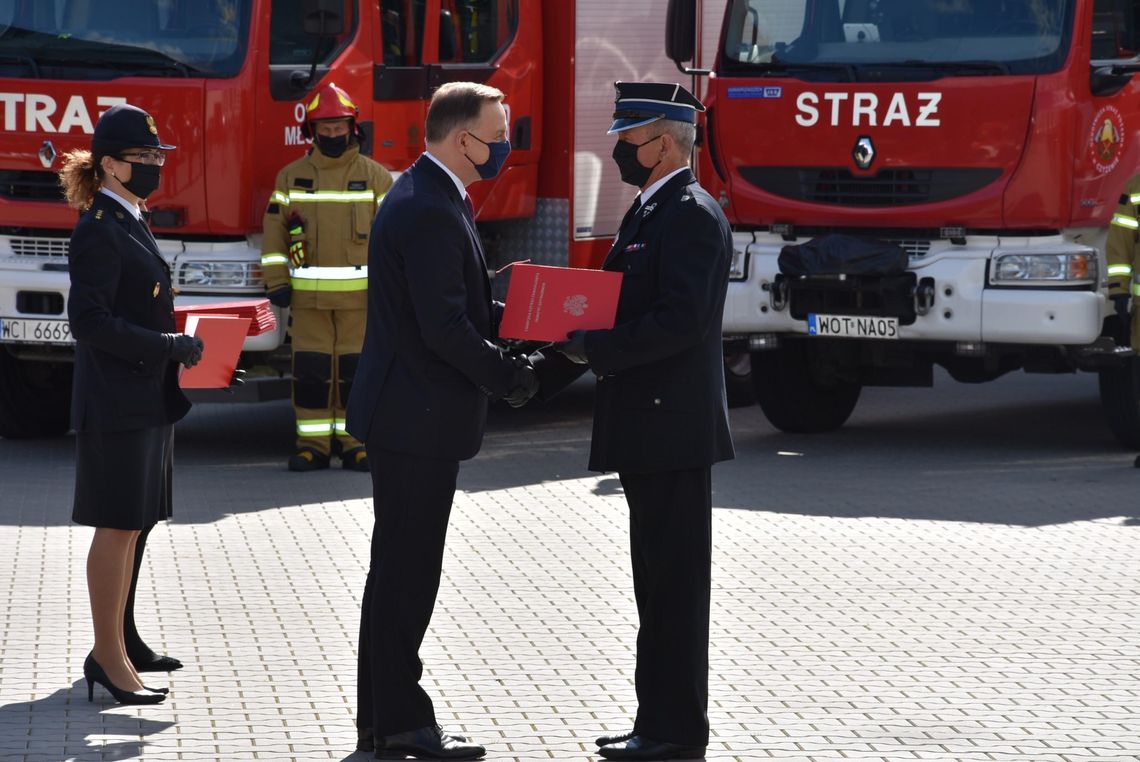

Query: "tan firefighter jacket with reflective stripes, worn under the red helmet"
left=261, top=146, right=392, bottom=310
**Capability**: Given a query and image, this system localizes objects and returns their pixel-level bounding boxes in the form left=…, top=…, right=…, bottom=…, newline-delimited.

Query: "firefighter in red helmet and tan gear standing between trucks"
left=261, top=82, right=392, bottom=471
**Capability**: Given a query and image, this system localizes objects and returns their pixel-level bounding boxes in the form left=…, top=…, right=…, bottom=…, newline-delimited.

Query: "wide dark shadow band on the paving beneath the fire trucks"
left=0, top=374, right=1140, bottom=526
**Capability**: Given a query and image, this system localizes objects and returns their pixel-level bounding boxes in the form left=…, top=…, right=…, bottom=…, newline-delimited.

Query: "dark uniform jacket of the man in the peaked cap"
left=538, top=169, right=734, bottom=473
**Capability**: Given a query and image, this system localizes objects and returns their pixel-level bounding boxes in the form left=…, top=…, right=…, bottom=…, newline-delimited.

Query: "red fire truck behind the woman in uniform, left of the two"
left=0, top=0, right=723, bottom=437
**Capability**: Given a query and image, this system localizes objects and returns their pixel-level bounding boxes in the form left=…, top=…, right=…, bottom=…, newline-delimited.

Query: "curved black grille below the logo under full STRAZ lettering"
left=740, top=167, right=1001, bottom=206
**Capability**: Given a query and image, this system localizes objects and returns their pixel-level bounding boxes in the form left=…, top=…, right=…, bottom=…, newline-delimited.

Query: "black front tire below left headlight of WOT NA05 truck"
left=752, top=341, right=863, bottom=433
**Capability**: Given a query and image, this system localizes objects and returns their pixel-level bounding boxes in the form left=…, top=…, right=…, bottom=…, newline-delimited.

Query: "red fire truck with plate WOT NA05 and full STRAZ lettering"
left=667, top=0, right=1140, bottom=447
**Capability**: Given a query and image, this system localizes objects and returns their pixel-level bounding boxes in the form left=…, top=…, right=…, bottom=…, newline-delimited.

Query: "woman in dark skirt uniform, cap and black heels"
left=59, top=104, right=202, bottom=704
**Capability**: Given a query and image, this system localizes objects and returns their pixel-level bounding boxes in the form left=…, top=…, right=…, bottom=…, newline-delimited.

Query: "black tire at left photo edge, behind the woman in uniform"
left=0, top=347, right=73, bottom=439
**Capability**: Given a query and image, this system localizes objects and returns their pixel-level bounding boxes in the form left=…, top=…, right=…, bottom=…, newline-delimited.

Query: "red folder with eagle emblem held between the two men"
left=499, top=265, right=621, bottom=341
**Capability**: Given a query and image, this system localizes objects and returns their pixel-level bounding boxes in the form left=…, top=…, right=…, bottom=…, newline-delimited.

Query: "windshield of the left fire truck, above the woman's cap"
left=0, top=0, right=251, bottom=80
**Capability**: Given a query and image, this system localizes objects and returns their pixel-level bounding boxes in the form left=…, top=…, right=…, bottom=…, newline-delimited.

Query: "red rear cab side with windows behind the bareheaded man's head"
left=374, top=0, right=542, bottom=220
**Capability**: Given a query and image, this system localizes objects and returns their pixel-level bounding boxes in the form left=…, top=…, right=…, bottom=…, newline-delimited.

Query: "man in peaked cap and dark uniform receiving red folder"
left=537, top=82, right=733, bottom=760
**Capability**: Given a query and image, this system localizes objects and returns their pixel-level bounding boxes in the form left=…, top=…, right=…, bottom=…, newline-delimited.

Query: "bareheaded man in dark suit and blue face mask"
left=348, top=82, right=538, bottom=760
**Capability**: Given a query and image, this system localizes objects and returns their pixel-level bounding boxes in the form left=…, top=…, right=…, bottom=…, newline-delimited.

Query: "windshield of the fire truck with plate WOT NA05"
left=719, top=0, right=1074, bottom=81
